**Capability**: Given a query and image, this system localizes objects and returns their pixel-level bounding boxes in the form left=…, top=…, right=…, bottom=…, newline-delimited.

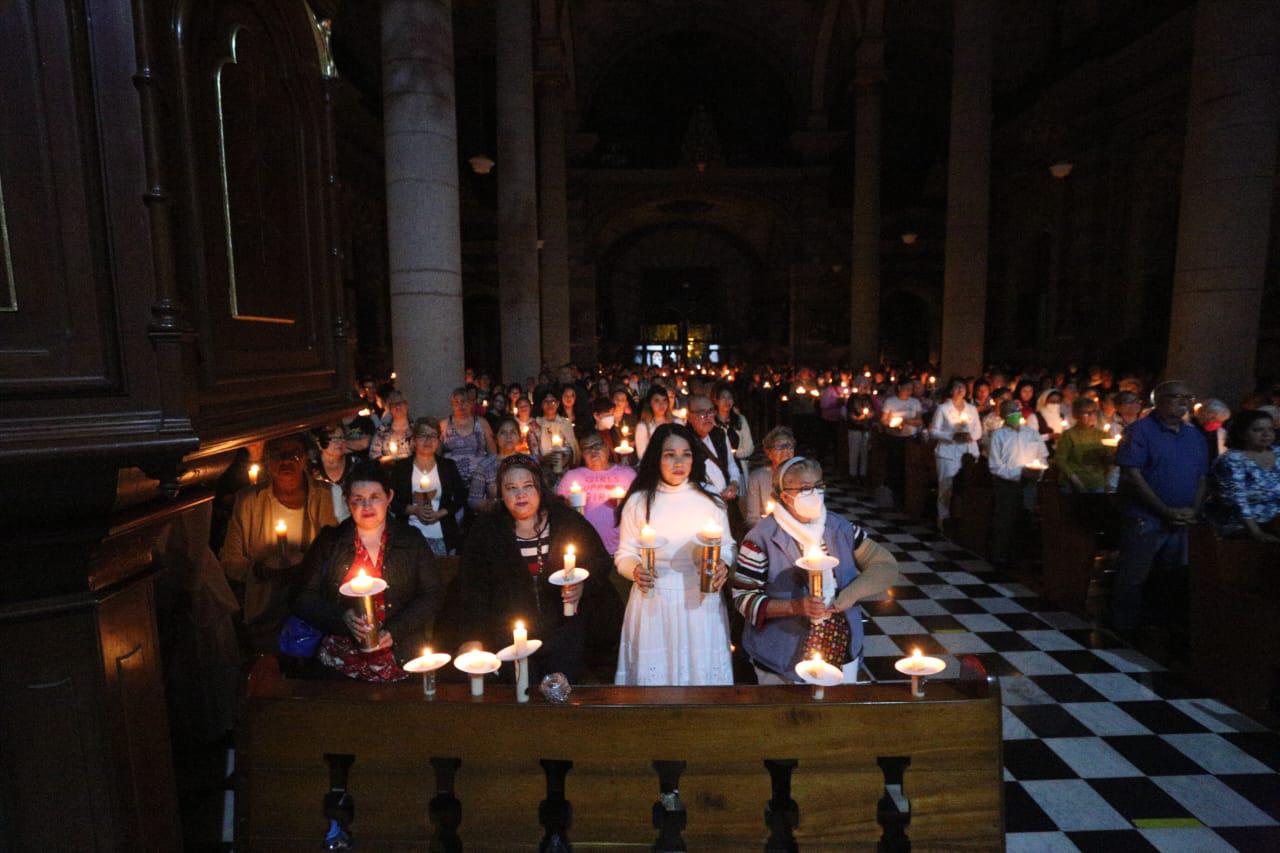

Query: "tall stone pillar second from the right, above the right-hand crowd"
left=941, top=0, right=992, bottom=377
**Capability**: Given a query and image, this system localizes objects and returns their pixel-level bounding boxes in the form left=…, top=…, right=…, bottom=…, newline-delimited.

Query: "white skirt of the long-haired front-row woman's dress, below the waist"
left=614, top=579, right=733, bottom=686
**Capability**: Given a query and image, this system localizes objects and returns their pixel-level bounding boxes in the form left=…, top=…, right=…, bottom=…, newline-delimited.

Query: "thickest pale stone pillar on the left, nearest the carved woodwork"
left=381, top=0, right=463, bottom=414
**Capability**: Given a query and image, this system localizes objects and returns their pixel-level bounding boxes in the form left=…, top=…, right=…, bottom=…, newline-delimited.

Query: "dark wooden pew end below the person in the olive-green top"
left=1037, top=467, right=1097, bottom=611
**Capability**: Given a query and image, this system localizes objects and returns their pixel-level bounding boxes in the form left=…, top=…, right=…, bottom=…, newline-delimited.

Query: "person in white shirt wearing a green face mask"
left=987, top=400, right=1048, bottom=565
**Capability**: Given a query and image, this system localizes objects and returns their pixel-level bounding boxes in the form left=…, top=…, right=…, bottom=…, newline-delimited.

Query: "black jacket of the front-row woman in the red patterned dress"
left=293, top=519, right=444, bottom=663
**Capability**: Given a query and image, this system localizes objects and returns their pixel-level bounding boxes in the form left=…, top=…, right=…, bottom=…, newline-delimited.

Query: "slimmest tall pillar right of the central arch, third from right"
left=849, top=0, right=884, bottom=366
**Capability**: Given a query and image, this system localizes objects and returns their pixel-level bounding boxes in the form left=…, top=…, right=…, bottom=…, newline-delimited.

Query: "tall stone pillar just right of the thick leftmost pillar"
left=497, top=0, right=543, bottom=382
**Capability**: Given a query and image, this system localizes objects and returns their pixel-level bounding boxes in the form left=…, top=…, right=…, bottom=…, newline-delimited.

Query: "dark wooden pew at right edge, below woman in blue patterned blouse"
left=1189, top=524, right=1280, bottom=721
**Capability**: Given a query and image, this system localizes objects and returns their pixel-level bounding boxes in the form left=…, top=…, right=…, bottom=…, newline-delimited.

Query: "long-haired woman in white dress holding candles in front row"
left=613, top=424, right=735, bottom=685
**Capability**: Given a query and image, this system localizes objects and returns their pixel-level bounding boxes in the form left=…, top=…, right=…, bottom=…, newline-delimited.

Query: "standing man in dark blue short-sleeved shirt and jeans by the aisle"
left=1111, top=380, right=1208, bottom=631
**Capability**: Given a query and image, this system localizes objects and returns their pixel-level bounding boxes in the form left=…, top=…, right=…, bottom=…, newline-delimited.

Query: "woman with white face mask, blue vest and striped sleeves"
left=733, top=457, right=897, bottom=684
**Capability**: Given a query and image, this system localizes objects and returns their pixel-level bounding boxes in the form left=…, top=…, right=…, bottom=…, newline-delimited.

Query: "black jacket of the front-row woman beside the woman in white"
left=458, top=501, right=622, bottom=681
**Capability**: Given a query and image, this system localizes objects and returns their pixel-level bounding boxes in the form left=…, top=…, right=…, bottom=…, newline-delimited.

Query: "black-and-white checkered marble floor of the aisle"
left=827, top=484, right=1280, bottom=853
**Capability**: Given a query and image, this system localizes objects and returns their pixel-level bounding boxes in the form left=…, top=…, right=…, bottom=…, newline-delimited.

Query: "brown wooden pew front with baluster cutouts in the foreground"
left=236, top=658, right=1004, bottom=850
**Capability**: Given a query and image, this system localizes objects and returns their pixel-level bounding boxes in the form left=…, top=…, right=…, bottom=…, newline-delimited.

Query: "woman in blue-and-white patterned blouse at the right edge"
left=1210, top=409, right=1280, bottom=542
